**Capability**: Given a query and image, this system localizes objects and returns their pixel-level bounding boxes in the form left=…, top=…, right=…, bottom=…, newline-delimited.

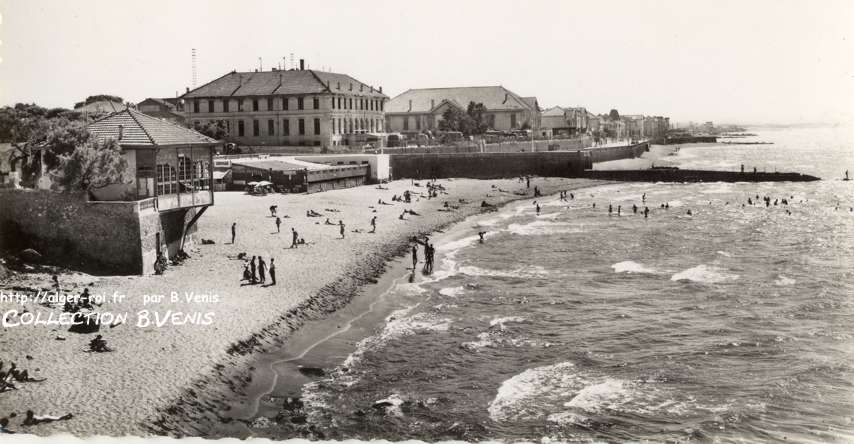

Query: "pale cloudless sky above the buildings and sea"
left=0, top=0, right=854, bottom=123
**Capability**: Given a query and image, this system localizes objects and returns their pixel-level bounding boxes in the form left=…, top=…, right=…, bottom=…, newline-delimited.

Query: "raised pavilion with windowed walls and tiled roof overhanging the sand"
left=87, top=109, right=221, bottom=274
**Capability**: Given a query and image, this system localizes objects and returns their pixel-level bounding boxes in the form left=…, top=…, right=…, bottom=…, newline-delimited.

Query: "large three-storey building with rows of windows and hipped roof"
left=186, top=61, right=388, bottom=151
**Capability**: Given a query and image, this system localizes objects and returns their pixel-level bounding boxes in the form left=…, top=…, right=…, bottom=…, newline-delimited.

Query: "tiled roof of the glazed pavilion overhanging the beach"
left=87, top=109, right=219, bottom=147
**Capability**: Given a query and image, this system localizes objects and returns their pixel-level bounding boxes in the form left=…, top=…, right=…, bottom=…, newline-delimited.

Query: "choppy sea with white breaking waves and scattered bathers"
left=261, top=128, right=854, bottom=442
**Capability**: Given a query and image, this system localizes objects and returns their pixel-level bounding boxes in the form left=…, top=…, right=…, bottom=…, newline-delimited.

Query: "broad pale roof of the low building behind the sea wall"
left=385, top=86, right=531, bottom=113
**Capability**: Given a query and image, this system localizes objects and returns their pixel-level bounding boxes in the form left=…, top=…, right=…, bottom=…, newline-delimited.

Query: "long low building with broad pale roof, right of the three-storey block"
left=385, top=86, right=540, bottom=132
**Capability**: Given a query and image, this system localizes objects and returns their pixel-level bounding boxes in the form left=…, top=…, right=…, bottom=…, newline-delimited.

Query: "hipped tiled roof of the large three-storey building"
left=187, top=69, right=387, bottom=99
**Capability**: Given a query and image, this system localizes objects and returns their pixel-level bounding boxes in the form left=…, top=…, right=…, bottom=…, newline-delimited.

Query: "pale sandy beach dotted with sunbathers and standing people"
left=0, top=178, right=598, bottom=436
